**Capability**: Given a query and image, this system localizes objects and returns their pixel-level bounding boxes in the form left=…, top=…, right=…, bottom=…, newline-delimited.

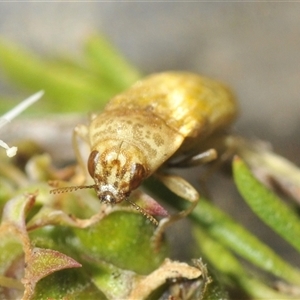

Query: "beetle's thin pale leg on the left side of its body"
left=72, top=124, right=89, bottom=180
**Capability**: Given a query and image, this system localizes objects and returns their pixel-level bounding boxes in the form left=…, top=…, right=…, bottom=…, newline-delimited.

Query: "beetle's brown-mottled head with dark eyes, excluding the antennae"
left=88, top=140, right=147, bottom=204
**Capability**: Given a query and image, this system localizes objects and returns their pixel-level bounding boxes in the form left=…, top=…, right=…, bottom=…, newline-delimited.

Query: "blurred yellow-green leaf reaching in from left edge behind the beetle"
left=0, top=40, right=117, bottom=112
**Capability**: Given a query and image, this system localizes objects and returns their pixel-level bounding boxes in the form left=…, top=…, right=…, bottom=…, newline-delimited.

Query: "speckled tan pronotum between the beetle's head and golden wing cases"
left=89, top=106, right=184, bottom=173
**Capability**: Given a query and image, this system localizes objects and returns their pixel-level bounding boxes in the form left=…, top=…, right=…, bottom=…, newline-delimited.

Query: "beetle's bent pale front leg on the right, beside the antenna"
left=152, top=173, right=199, bottom=250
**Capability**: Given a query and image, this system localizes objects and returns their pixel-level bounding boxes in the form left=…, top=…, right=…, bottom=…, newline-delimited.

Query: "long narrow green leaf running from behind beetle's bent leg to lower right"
left=146, top=179, right=300, bottom=284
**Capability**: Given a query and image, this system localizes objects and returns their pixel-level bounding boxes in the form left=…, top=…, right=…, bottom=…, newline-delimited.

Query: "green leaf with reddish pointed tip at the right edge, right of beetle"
left=233, top=158, right=300, bottom=251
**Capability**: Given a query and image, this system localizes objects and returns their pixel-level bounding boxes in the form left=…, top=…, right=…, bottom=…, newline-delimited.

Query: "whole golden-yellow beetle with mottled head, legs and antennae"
left=52, top=71, right=237, bottom=244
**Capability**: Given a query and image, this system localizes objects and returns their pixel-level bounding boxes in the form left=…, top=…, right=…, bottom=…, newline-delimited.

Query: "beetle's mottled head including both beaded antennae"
left=50, top=143, right=158, bottom=225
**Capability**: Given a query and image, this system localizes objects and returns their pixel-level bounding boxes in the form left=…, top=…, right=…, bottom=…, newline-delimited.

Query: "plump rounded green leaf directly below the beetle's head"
left=74, top=211, right=166, bottom=274
